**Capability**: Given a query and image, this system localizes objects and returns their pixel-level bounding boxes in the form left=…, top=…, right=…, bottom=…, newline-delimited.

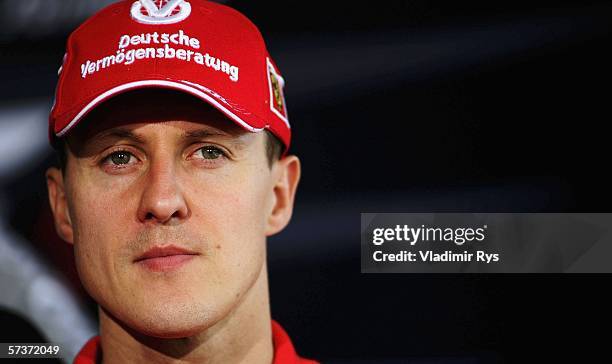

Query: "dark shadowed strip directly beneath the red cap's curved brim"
left=67, top=89, right=252, bottom=145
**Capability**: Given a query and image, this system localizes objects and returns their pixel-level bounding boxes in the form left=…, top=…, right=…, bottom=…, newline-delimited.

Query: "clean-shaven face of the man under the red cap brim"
left=45, top=91, right=299, bottom=337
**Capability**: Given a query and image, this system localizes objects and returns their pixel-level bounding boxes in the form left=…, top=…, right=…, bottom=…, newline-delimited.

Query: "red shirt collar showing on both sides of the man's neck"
left=74, top=320, right=318, bottom=364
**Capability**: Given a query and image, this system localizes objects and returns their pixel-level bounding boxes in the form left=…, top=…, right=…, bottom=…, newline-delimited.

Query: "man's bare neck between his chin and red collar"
left=99, top=264, right=274, bottom=364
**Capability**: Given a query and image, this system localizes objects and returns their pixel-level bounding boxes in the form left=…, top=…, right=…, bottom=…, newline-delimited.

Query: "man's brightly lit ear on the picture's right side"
left=266, top=155, right=301, bottom=236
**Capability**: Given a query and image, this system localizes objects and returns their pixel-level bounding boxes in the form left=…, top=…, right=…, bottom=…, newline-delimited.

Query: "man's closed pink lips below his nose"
left=134, top=245, right=199, bottom=272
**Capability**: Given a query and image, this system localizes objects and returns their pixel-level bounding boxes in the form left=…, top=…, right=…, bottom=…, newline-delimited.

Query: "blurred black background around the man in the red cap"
left=0, top=1, right=612, bottom=363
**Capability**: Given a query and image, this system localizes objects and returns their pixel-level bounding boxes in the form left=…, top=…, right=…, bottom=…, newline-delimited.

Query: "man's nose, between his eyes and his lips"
left=138, top=161, right=190, bottom=225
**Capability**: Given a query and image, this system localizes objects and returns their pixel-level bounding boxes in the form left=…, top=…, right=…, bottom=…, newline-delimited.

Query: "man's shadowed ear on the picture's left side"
left=45, top=167, right=73, bottom=244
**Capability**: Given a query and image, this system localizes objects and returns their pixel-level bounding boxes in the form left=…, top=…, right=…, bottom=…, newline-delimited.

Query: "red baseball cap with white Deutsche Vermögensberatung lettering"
left=49, top=0, right=291, bottom=150
